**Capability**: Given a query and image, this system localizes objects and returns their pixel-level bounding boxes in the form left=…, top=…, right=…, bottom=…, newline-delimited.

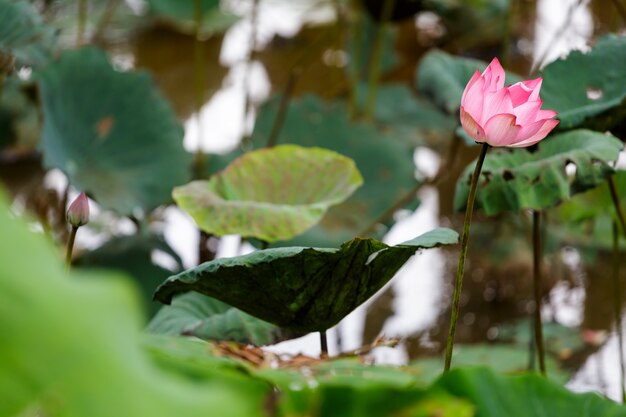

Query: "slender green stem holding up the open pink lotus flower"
left=443, top=143, right=489, bottom=372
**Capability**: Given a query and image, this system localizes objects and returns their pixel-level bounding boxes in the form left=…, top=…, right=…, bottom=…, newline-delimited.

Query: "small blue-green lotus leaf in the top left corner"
left=0, top=0, right=56, bottom=69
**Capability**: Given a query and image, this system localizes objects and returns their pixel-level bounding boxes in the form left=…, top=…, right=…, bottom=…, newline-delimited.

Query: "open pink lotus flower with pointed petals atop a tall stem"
left=461, top=58, right=559, bottom=148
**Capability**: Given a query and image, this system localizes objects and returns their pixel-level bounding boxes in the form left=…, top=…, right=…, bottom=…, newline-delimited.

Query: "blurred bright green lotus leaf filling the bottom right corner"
left=434, top=368, right=626, bottom=417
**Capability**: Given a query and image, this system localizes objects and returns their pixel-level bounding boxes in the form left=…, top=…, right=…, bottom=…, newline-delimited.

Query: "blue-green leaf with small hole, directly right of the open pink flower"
left=541, top=35, right=626, bottom=130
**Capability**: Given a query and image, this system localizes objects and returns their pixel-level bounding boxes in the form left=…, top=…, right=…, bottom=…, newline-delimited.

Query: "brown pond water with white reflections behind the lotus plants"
left=4, top=0, right=626, bottom=399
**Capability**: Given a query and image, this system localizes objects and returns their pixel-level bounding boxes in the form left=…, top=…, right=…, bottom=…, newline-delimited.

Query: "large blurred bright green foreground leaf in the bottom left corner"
left=0, top=193, right=267, bottom=417
